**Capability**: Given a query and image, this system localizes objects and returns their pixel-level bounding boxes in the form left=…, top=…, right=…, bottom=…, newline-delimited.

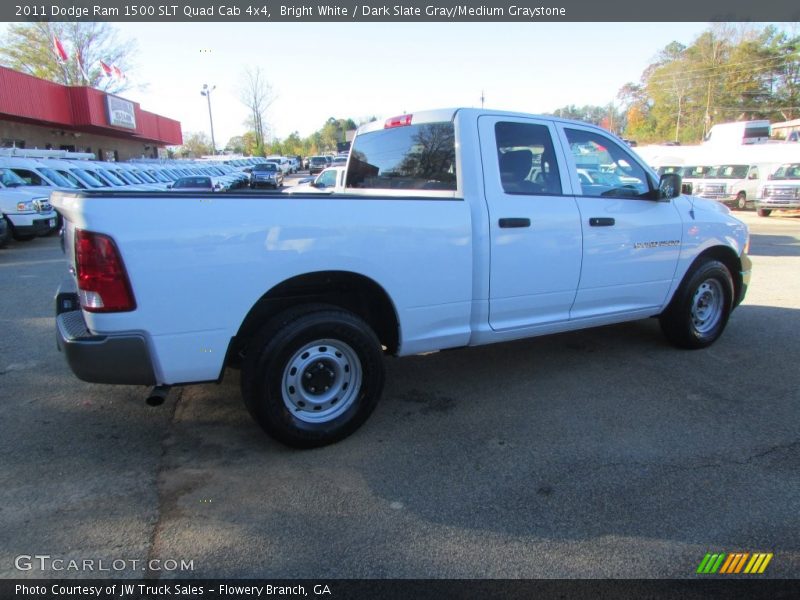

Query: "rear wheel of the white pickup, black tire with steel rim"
left=241, top=304, right=384, bottom=448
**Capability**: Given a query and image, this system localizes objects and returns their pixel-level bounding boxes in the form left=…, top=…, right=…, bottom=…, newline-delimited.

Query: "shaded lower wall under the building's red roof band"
left=0, top=121, right=158, bottom=160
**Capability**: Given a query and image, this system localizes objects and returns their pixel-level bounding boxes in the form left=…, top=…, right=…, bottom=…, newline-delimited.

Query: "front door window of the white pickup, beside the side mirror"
left=565, top=129, right=650, bottom=198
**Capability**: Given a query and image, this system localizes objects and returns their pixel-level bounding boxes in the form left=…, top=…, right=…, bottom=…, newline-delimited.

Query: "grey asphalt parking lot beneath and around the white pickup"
left=0, top=212, right=800, bottom=578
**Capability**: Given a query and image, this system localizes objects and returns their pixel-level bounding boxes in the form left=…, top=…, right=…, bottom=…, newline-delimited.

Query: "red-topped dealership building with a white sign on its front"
left=0, top=67, right=183, bottom=160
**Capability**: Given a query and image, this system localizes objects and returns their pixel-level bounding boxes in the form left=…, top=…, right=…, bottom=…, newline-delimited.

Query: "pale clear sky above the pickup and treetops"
left=0, top=22, right=724, bottom=148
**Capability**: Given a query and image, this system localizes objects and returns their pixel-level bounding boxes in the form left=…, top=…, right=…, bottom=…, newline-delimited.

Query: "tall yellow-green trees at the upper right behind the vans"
left=617, top=24, right=800, bottom=143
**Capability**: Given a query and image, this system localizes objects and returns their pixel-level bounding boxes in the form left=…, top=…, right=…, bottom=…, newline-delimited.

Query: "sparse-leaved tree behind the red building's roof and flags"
left=0, top=21, right=136, bottom=93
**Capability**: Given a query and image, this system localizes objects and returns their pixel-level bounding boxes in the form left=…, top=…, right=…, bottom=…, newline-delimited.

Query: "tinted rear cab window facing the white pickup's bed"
left=345, top=113, right=458, bottom=197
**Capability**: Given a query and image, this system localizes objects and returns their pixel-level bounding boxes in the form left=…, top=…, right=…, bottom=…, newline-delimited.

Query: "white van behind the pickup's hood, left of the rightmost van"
left=692, top=163, right=774, bottom=210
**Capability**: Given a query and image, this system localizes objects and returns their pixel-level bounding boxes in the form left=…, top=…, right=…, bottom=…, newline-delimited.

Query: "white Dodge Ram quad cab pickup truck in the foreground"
left=52, top=109, right=750, bottom=447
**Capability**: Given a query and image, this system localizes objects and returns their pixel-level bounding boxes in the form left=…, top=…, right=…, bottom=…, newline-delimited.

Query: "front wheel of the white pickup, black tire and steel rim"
left=659, top=258, right=733, bottom=350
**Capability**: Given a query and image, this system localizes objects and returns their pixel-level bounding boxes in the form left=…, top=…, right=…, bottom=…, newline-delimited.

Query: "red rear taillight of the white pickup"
left=75, top=229, right=136, bottom=312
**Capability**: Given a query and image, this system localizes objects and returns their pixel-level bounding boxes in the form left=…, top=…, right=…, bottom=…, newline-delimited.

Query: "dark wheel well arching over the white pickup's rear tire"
left=227, top=271, right=400, bottom=366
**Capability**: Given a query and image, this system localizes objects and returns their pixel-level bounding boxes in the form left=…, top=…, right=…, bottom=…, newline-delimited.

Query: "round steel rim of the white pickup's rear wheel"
left=281, top=339, right=363, bottom=423
